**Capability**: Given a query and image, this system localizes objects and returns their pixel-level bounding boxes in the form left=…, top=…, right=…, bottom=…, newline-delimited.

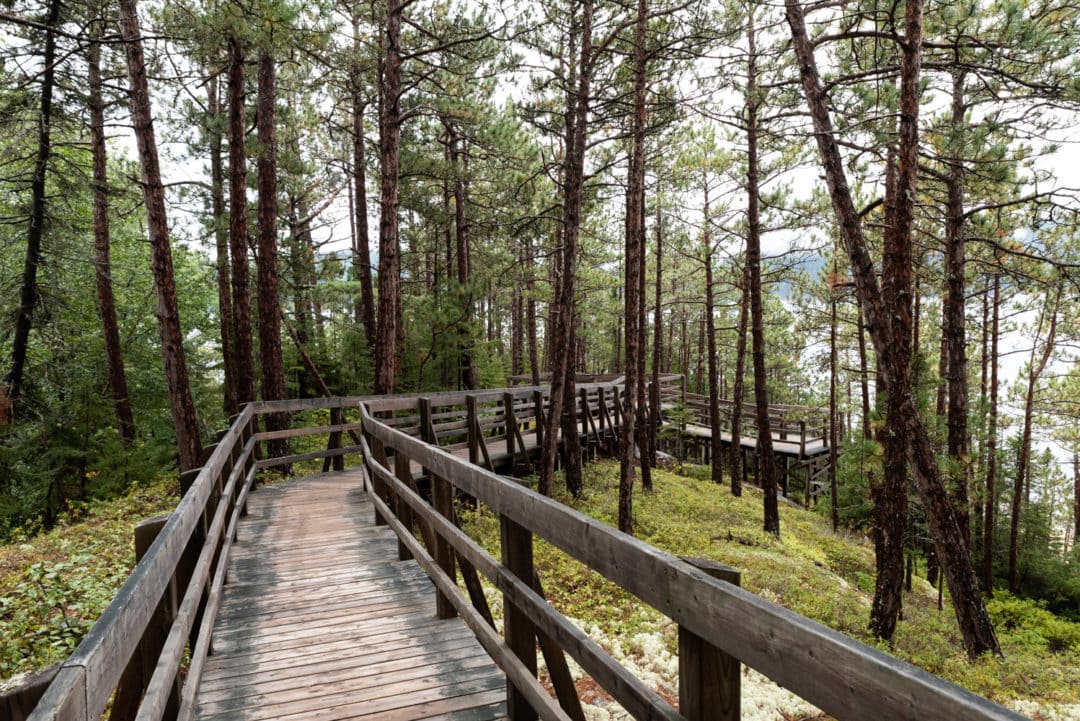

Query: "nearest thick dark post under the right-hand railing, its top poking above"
left=678, top=558, right=742, bottom=721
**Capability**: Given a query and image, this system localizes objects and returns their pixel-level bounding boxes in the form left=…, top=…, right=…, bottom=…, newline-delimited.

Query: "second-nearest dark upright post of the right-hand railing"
left=499, top=516, right=538, bottom=721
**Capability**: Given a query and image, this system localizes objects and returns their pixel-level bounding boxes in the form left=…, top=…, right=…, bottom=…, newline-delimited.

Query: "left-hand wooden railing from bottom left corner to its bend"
left=23, top=406, right=257, bottom=721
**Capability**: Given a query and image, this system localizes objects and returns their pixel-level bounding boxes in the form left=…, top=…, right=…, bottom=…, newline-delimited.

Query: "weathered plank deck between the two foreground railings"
left=197, top=470, right=507, bottom=721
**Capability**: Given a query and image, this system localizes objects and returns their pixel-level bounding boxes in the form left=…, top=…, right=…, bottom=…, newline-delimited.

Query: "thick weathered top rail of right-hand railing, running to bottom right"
left=361, top=405, right=1024, bottom=721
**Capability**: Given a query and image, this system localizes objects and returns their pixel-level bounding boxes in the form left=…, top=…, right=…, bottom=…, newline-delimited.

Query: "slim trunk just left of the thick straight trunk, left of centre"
left=351, top=19, right=376, bottom=351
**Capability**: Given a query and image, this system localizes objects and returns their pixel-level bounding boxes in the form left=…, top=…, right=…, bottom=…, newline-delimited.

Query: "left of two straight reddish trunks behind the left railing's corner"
left=228, top=37, right=255, bottom=407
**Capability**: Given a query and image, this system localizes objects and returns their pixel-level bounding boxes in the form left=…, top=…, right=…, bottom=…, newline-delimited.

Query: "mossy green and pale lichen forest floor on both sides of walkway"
left=0, top=461, right=1080, bottom=721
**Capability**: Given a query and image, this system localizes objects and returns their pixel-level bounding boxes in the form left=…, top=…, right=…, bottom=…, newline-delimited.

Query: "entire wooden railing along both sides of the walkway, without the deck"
left=19, top=379, right=1023, bottom=721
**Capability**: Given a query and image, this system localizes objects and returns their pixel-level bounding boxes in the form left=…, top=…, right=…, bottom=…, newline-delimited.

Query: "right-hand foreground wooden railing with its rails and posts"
left=361, top=386, right=1024, bottom=721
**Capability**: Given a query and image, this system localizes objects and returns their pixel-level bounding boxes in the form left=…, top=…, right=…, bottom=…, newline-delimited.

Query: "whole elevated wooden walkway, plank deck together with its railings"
left=14, top=382, right=1024, bottom=721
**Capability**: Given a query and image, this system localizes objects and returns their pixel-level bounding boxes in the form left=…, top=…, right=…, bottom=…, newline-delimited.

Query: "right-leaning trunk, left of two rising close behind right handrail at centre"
left=539, top=0, right=591, bottom=495
